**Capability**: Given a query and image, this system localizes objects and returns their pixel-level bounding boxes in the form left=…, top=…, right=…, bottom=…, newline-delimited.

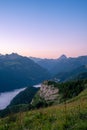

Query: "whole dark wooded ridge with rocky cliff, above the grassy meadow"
left=0, top=79, right=87, bottom=117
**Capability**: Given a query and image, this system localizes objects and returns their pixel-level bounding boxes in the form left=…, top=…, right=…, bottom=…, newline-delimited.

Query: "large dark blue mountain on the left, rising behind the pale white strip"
left=0, top=53, right=50, bottom=92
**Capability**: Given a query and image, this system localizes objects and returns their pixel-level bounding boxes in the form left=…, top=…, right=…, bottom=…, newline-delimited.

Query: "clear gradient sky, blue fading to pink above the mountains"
left=0, top=0, right=87, bottom=58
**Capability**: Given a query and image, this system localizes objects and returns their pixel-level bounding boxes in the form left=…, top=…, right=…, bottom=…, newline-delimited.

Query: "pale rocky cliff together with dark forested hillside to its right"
left=31, top=80, right=87, bottom=108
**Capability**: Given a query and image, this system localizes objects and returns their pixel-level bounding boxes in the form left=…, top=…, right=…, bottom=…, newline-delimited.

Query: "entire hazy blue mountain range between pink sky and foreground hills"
left=0, top=53, right=87, bottom=92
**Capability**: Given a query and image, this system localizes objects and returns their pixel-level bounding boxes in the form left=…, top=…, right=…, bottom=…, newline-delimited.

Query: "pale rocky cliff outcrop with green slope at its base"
left=31, top=81, right=59, bottom=106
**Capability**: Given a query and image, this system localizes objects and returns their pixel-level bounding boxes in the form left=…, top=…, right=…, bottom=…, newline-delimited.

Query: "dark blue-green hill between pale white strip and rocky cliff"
left=0, top=87, right=39, bottom=117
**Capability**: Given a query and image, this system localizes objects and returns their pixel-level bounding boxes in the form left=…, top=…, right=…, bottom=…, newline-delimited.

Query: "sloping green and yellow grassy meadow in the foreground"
left=0, top=89, right=87, bottom=130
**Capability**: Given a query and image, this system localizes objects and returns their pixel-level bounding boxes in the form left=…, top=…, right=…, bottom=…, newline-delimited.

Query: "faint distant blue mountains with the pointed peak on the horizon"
left=31, top=55, right=87, bottom=74
